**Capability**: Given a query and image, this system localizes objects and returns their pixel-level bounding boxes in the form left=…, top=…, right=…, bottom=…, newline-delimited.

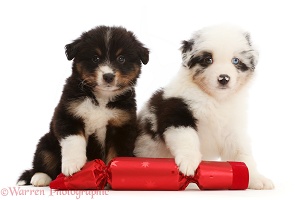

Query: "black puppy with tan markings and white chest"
left=18, top=26, right=149, bottom=186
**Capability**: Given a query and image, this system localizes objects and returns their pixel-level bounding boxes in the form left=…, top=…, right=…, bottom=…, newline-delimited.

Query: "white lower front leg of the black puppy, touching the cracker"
left=60, top=135, right=87, bottom=176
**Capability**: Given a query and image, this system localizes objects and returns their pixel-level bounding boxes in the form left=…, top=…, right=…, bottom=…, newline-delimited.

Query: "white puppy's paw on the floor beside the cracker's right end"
left=248, top=174, right=274, bottom=190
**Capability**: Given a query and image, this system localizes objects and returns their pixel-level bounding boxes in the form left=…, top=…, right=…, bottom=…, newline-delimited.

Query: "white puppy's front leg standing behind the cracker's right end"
left=222, top=134, right=274, bottom=190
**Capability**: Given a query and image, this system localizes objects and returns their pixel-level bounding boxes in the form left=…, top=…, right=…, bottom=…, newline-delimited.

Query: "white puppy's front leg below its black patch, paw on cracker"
left=164, top=127, right=202, bottom=175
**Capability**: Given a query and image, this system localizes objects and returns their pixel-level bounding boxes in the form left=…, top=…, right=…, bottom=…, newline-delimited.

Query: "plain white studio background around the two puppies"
left=0, top=0, right=298, bottom=199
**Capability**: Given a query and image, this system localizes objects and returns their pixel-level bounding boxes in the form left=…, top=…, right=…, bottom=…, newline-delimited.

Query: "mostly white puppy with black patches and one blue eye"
left=134, top=25, right=273, bottom=189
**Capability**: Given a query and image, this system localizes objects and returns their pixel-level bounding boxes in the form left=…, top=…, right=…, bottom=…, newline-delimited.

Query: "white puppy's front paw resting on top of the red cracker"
left=175, top=155, right=202, bottom=176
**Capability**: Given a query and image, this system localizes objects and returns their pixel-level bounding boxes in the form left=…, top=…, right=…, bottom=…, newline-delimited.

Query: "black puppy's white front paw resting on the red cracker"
left=62, top=156, right=87, bottom=176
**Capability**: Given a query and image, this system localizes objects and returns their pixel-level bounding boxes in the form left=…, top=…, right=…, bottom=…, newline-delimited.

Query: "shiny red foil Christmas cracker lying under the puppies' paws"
left=50, top=157, right=248, bottom=190
